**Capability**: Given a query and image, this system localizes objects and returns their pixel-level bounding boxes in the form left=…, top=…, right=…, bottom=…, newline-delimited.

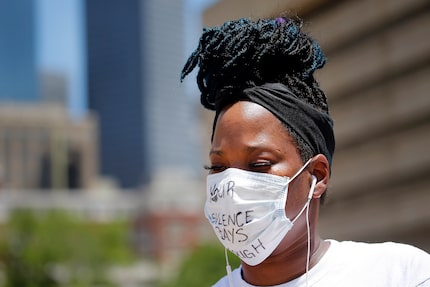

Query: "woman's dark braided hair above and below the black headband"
left=181, top=17, right=328, bottom=169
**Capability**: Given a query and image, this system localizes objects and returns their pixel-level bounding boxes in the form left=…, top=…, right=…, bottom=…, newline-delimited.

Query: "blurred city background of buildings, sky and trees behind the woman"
left=0, top=0, right=430, bottom=287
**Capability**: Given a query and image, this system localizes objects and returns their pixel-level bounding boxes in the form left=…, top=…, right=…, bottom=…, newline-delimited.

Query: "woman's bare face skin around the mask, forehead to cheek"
left=209, top=101, right=311, bottom=227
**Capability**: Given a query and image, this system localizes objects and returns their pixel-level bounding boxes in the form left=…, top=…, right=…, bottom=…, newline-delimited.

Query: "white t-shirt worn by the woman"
left=213, top=240, right=430, bottom=287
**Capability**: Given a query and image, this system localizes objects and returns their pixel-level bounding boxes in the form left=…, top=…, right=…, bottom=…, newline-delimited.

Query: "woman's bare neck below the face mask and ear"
left=242, top=202, right=329, bottom=286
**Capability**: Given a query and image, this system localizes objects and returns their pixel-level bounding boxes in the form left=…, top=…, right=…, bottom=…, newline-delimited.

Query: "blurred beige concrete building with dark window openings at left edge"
left=0, top=103, right=99, bottom=191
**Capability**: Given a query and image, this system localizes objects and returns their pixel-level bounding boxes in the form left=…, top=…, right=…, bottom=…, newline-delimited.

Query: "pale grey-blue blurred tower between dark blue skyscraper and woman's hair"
left=142, top=0, right=201, bottom=176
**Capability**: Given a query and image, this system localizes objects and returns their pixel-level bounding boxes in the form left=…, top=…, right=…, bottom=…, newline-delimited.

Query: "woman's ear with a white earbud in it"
left=308, top=154, right=330, bottom=198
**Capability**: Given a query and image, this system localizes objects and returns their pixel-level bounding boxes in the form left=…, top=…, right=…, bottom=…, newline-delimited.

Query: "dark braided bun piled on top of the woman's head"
left=181, top=18, right=325, bottom=97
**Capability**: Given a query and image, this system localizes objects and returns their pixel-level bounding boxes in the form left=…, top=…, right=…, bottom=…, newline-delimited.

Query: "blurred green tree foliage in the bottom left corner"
left=0, top=210, right=134, bottom=287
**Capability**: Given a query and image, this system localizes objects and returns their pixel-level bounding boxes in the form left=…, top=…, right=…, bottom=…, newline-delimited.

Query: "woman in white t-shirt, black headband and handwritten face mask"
left=181, top=17, right=430, bottom=287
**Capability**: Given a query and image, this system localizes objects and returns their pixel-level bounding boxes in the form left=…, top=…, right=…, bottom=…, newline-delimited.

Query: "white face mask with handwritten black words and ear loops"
left=205, top=160, right=315, bottom=266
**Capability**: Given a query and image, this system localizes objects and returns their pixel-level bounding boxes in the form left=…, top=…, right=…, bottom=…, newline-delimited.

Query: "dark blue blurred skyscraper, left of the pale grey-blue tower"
left=86, top=0, right=148, bottom=188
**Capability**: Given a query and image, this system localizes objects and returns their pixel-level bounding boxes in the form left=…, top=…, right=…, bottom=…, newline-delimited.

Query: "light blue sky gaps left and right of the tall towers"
left=35, top=0, right=216, bottom=118
